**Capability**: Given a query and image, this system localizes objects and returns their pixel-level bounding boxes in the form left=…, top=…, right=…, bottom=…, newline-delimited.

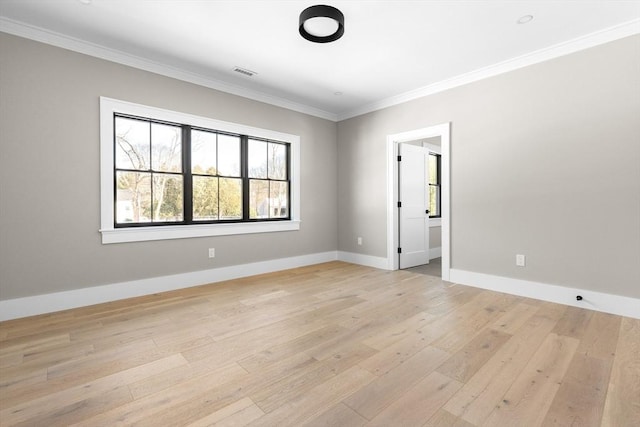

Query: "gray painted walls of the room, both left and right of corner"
left=0, top=34, right=640, bottom=299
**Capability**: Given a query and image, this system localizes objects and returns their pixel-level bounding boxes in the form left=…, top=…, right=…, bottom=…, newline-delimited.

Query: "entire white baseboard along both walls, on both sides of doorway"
left=5, top=251, right=640, bottom=321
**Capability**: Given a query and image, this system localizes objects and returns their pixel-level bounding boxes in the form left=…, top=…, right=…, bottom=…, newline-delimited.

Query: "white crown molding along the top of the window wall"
left=0, top=17, right=338, bottom=122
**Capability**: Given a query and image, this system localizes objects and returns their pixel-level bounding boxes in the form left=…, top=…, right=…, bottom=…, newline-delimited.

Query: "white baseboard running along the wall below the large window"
left=0, top=251, right=338, bottom=321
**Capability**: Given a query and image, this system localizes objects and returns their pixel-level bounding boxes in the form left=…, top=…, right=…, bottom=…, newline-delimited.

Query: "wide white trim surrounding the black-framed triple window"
left=100, top=97, right=300, bottom=244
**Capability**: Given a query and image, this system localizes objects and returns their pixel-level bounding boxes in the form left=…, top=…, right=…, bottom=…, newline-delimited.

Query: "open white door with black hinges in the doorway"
left=398, top=144, right=429, bottom=268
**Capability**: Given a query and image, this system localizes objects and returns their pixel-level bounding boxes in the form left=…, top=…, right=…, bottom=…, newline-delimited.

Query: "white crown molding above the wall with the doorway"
left=338, top=19, right=640, bottom=121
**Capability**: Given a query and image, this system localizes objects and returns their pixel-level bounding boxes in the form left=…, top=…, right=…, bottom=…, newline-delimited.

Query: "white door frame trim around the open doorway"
left=387, top=122, right=451, bottom=281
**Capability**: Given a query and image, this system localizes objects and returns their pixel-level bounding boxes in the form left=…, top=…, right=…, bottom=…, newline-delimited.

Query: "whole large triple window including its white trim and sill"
left=101, top=98, right=299, bottom=243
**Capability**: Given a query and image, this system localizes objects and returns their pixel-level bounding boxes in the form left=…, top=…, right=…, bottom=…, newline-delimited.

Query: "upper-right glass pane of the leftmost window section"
left=151, top=123, right=182, bottom=172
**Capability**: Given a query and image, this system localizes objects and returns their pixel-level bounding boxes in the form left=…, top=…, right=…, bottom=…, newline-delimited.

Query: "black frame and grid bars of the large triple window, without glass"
left=112, top=112, right=292, bottom=229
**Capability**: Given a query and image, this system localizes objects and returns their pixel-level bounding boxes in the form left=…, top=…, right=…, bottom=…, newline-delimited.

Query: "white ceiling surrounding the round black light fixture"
left=0, top=0, right=640, bottom=120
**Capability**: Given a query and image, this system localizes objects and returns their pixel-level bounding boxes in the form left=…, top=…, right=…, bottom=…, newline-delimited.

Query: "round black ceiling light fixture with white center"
left=298, top=5, right=344, bottom=43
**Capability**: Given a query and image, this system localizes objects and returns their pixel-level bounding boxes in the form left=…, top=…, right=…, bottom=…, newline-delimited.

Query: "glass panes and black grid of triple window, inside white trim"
left=114, top=114, right=291, bottom=227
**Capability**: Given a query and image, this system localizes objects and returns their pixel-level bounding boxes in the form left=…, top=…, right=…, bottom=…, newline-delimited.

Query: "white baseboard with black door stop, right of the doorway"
left=449, top=269, right=640, bottom=319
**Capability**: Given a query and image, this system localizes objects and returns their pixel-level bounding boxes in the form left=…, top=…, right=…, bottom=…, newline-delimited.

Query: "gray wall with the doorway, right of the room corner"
left=338, top=36, right=640, bottom=298
